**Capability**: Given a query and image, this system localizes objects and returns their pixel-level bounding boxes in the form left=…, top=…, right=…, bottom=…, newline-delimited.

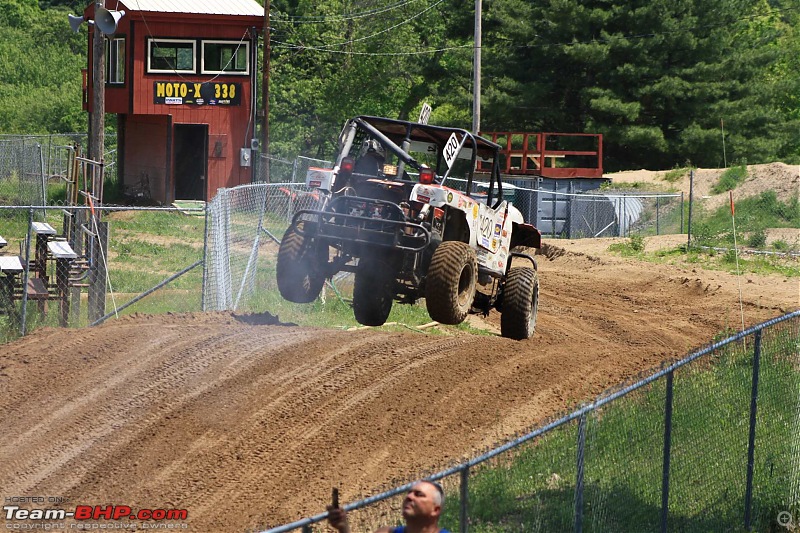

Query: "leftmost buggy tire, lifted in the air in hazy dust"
left=276, top=221, right=327, bottom=304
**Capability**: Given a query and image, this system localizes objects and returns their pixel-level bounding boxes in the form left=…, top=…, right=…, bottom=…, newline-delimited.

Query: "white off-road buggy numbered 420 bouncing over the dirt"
left=277, top=116, right=541, bottom=339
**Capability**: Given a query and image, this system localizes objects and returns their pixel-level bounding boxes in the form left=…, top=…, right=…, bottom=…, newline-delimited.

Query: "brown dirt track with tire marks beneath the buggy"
left=0, top=239, right=800, bottom=531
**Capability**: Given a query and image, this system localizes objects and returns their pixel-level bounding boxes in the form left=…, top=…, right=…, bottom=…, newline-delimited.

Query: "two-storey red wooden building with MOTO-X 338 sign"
left=83, top=0, right=264, bottom=203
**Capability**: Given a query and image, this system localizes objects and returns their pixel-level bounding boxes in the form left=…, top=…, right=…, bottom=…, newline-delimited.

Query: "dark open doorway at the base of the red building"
left=175, top=124, right=208, bottom=200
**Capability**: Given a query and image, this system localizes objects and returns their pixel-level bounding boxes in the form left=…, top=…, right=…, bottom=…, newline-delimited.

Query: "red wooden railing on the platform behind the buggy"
left=476, top=131, right=603, bottom=178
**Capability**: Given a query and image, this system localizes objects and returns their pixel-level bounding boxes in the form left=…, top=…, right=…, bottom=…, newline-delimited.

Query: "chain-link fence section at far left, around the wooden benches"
left=0, top=202, right=205, bottom=343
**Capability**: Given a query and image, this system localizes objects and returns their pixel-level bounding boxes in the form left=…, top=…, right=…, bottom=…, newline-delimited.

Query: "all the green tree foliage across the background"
left=0, top=0, right=800, bottom=171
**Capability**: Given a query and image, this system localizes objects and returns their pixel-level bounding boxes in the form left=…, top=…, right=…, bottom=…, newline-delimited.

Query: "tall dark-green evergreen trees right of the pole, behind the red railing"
left=483, top=0, right=791, bottom=170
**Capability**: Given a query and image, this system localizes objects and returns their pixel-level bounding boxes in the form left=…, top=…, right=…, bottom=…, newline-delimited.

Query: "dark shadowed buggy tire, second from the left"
left=353, top=258, right=395, bottom=326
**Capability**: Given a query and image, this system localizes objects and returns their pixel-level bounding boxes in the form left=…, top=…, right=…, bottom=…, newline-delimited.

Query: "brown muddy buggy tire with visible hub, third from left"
left=425, top=241, right=478, bottom=324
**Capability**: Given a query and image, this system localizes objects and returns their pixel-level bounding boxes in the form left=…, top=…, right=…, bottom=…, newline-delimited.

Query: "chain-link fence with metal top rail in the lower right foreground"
left=268, top=311, right=800, bottom=533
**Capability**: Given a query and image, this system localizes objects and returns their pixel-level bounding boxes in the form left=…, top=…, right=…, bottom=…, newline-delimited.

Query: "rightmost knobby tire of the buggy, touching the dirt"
left=500, top=267, right=539, bottom=341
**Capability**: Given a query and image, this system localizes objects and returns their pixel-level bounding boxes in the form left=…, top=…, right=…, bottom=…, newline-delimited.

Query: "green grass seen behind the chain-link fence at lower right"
left=442, top=326, right=800, bottom=533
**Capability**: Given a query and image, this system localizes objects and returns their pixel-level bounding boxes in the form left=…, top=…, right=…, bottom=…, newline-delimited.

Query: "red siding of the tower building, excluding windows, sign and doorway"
left=86, top=6, right=263, bottom=202
